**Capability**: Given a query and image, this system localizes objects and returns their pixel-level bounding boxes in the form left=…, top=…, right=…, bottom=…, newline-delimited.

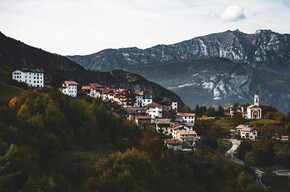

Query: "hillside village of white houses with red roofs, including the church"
left=12, top=68, right=289, bottom=151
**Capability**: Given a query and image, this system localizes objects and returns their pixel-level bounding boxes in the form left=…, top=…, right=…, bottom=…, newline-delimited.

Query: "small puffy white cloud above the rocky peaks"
left=221, top=5, right=246, bottom=21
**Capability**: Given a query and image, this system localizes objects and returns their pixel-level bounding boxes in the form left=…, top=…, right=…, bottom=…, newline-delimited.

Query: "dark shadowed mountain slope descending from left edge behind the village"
left=0, top=32, right=184, bottom=107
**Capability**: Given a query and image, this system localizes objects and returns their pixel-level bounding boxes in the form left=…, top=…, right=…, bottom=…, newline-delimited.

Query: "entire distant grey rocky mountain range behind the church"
left=67, top=30, right=290, bottom=113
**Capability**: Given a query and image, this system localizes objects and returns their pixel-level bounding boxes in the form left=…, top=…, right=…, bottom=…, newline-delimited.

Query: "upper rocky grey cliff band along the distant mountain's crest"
left=67, top=30, right=290, bottom=73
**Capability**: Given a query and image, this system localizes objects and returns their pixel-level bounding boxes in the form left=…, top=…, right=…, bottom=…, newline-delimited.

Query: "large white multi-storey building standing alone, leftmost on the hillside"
left=12, top=68, right=44, bottom=87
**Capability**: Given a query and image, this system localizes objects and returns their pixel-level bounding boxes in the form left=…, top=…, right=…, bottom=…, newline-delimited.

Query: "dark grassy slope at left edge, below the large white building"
left=0, top=82, right=23, bottom=104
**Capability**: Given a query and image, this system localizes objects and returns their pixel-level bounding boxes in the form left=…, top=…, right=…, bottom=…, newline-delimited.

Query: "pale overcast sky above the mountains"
left=0, top=0, right=290, bottom=55
